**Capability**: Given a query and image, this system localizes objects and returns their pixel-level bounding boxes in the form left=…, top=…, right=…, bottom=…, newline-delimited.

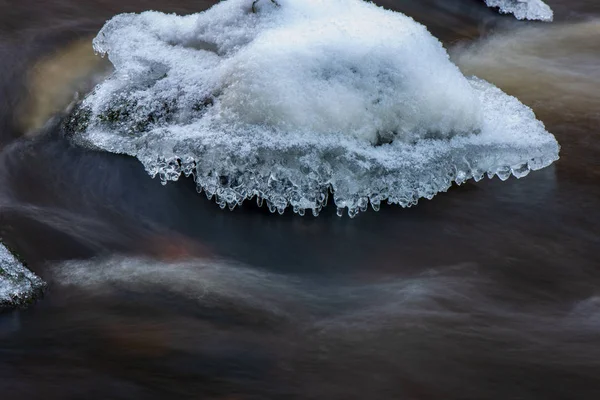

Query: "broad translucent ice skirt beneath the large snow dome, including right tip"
left=75, top=77, right=560, bottom=218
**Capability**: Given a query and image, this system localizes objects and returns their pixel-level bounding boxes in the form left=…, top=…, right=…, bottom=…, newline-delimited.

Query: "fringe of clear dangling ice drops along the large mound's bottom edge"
left=151, top=141, right=558, bottom=218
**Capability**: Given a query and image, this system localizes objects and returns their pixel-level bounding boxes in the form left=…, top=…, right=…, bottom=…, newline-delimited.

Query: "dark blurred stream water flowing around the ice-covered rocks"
left=0, top=0, right=600, bottom=400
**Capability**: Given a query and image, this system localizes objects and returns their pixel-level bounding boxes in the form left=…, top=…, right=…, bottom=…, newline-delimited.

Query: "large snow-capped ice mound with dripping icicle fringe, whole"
left=66, top=0, right=558, bottom=216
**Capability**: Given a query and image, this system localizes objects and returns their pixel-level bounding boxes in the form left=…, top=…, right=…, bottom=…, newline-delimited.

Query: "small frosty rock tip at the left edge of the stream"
left=0, top=243, right=46, bottom=311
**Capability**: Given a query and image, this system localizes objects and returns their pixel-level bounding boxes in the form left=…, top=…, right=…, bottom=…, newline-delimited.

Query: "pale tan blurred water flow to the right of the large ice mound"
left=453, top=19, right=600, bottom=115
